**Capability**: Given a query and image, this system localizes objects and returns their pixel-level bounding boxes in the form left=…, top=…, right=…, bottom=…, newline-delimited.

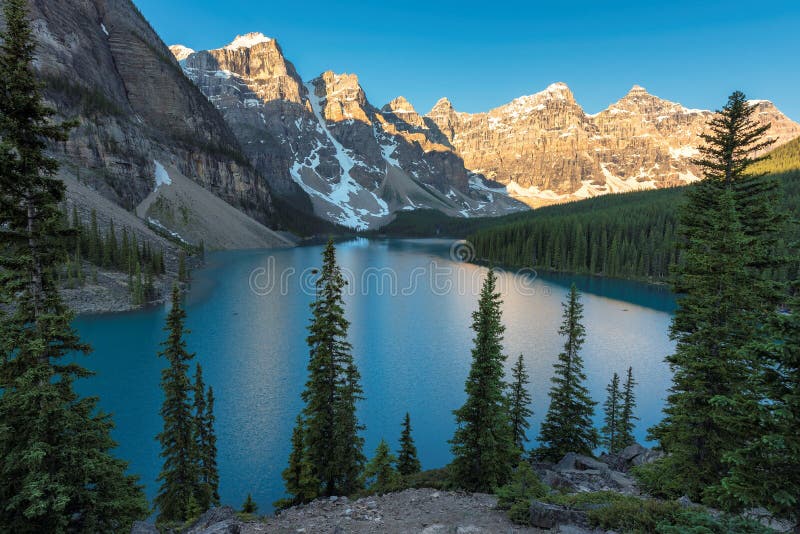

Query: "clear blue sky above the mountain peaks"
left=134, top=0, right=800, bottom=121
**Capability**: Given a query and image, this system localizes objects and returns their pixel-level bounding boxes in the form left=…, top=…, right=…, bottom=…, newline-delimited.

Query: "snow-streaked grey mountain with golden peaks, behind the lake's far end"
left=171, top=33, right=526, bottom=229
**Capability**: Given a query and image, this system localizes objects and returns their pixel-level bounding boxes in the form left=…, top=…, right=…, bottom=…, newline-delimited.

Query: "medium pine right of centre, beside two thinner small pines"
left=535, top=284, right=598, bottom=462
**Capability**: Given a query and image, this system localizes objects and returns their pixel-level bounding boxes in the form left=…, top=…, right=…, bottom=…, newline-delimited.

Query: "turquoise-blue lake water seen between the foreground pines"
left=75, top=239, right=675, bottom=512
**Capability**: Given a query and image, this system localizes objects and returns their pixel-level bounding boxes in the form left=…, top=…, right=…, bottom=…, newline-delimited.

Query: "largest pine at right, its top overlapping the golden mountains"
left=642, top=92, right=783, bottom=500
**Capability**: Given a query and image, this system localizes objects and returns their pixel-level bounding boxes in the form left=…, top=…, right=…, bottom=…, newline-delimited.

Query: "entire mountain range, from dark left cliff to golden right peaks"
left=17, top=0, right=800, bottom=238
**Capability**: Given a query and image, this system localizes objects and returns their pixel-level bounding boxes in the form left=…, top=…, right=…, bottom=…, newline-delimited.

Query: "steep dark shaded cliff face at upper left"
left=18, top=0, right=272, bottom=226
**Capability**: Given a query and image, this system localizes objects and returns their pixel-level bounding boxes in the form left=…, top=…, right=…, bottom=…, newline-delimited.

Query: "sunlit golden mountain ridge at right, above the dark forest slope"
left=424, top=83, right=800, bottom=206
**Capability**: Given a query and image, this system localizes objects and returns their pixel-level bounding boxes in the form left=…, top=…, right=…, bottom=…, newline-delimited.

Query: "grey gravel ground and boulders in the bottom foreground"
left=132, top=445, right=792, bottom=534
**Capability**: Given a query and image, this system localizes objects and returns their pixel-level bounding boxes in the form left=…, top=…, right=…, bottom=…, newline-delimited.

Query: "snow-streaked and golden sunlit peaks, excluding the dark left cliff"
left=170, top=33, right=800, bottom=227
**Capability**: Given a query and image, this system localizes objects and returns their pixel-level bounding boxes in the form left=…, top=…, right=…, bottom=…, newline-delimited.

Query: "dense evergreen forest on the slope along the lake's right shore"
left=468, top=169, right=800, bottom=281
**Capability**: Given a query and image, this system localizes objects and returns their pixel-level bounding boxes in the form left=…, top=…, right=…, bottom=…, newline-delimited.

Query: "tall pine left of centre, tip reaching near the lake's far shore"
left=287, top=240, right=365, bottom=499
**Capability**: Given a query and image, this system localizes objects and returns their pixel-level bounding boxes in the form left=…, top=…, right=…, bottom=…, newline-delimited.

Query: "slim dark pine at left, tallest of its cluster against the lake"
left=155, top=286, right=198, bottom=522
